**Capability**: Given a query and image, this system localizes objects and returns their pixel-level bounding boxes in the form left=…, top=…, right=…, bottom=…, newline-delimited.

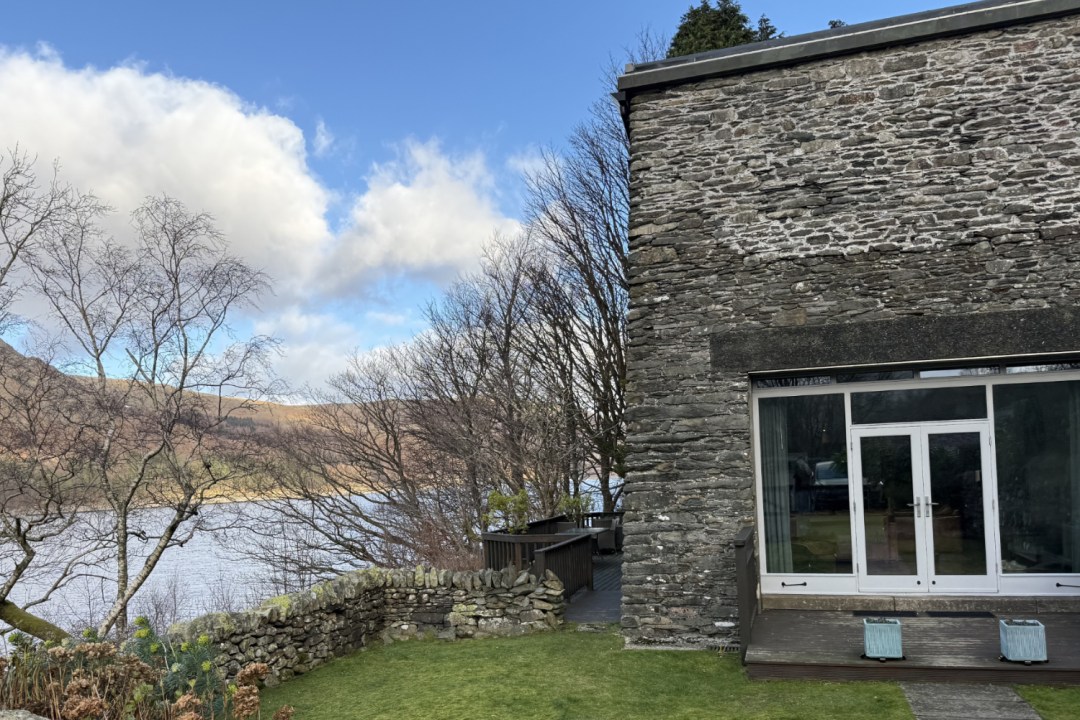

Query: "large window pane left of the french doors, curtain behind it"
left=758, top=395, right=852, bottom=573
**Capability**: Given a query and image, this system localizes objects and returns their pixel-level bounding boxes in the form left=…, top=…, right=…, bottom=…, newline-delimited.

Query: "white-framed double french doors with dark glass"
left=850, top=421, right=998, bottom=593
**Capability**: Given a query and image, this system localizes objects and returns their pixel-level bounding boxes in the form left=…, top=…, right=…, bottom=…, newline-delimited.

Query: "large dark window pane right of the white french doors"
left=994, top=382, right=1080, bottom=573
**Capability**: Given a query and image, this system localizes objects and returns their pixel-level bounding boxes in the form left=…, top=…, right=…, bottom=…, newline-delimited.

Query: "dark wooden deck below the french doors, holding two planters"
left=746, top=610, right=1080, bottom=684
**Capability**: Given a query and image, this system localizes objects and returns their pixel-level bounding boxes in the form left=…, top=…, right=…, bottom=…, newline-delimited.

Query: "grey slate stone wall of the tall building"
left=622, top=17, right=1080, bottom=644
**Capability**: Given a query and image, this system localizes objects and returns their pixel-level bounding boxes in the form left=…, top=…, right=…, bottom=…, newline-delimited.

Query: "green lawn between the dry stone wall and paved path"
left=262, top=629, right=912, bottom=720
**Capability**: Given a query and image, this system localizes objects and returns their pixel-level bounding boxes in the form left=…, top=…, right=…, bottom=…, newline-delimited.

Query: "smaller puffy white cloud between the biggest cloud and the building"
left=324, top=140, right=521, bottom=295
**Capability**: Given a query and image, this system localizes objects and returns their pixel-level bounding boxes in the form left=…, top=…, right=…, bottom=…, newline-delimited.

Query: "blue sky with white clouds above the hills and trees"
left=0, top=0, right=947, bottom=384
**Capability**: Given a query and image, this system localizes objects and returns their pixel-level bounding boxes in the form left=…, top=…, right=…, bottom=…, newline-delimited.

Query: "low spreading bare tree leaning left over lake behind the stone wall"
left=248, top=349, right=477, bottom=583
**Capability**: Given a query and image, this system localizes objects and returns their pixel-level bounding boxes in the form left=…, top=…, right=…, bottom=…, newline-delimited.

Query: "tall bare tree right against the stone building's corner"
left=528, top=32, right=666, bottom=512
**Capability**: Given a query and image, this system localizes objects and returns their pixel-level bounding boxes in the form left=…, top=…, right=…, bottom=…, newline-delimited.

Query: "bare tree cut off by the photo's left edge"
left=0, top=147, right=105, bottom=639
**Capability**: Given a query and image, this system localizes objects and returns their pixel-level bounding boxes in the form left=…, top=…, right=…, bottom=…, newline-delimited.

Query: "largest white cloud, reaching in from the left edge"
left=0, top=49, right=330, bottom=298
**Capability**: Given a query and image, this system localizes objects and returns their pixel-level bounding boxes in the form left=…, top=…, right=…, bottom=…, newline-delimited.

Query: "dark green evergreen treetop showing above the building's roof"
left=667, top=0, right=781, bottom=57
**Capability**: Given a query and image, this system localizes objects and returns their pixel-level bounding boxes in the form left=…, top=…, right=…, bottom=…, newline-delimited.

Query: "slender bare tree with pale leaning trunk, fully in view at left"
left=33, top=196, right=273, bottom=636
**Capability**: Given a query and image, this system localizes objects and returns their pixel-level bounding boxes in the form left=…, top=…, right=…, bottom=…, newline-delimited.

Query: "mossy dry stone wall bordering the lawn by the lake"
left=170, top=567, right=565, bottom=684
